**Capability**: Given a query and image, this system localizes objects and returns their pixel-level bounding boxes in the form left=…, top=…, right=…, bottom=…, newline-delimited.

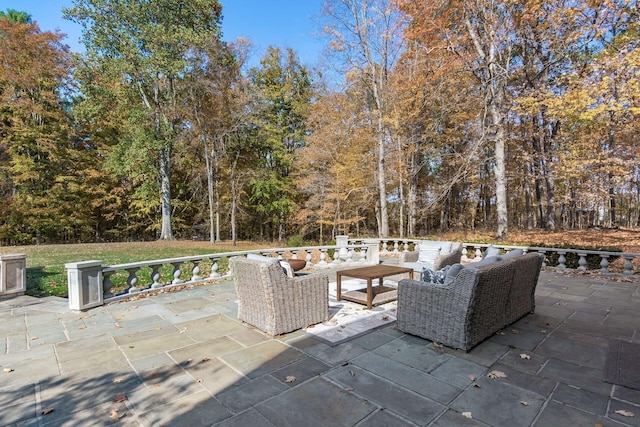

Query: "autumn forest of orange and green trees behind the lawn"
left=0, top=0, right=640, bottom=245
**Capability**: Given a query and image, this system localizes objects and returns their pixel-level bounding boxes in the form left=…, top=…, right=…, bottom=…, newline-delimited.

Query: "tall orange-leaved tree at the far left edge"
left=0, top=15, right=76, bottom=242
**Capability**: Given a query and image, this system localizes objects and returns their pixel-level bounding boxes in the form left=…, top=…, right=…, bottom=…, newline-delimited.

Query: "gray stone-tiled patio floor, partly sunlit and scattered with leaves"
left=0, top=260, right=640, bottom=427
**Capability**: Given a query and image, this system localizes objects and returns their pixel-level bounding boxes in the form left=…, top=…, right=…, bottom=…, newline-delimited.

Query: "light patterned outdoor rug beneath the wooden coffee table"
left=305, top=279, right=397, bottom=346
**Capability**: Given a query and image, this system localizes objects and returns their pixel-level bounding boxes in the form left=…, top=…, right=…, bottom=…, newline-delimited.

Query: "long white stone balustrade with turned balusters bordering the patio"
left=66, top=236, right=640, bottom=310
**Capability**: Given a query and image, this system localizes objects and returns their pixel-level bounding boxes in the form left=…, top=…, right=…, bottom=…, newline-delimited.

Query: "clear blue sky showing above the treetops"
left=0, top=0, right=324, bottom=66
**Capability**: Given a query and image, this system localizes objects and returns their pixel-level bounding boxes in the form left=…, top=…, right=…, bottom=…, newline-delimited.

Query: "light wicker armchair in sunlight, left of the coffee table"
left=229, top=257, right=329, bottom=335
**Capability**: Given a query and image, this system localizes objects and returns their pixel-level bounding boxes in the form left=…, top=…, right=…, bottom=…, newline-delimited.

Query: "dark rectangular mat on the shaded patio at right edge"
left=604, top=339, right=640, bottom=390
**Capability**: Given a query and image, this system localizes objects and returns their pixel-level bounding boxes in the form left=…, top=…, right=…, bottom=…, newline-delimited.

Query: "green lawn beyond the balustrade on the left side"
left=0, top=241, right=271, bottom=297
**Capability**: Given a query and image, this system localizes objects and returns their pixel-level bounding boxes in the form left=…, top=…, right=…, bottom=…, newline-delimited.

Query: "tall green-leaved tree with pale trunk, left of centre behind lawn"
left=64, top=0, right=222, bottom=239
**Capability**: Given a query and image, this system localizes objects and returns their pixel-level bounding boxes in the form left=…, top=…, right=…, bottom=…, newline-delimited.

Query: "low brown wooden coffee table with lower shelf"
left=336, top=265, right=413, bottom=308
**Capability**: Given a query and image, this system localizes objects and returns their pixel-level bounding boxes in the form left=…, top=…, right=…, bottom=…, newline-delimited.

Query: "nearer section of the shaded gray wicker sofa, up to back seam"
left=397, top=260, right=514, bottom=351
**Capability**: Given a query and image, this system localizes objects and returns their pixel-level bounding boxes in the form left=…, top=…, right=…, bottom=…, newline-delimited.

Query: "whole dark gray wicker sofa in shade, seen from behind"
left=397, top=253, right=544, bottom=351
